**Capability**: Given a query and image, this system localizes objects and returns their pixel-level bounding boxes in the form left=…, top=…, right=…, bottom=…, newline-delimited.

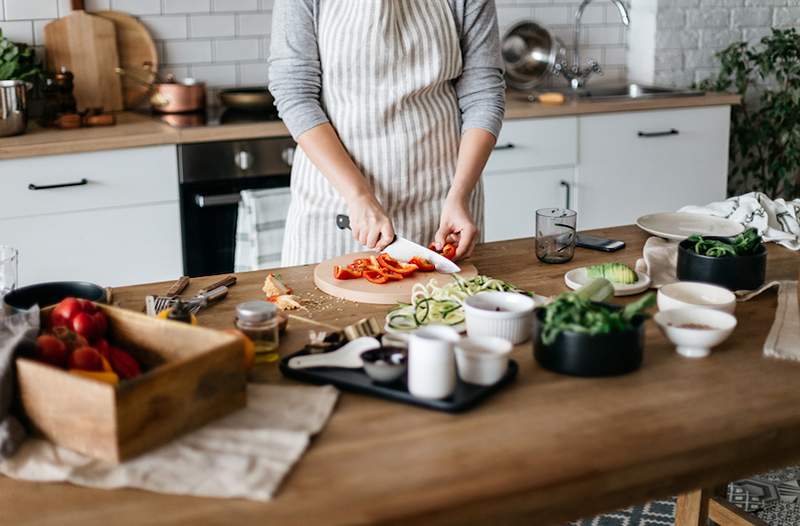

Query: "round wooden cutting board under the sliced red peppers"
left=314, top=252, right=478, bottom=305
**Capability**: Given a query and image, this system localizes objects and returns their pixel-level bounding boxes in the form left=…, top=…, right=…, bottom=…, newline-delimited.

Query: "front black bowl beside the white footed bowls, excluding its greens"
left=533, top=305, right=647, bottom=376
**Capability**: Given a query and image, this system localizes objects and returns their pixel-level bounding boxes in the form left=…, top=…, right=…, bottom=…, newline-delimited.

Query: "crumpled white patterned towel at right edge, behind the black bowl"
left=679, top=192, right=800, bottom=250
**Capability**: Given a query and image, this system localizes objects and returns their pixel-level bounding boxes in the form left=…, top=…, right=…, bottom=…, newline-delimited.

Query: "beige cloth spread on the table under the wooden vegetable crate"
left=0, top=384, right=338, bottom=501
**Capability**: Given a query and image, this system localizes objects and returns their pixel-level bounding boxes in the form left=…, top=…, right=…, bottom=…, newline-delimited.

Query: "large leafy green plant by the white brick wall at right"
left=700, top=28, right=800, bottom=198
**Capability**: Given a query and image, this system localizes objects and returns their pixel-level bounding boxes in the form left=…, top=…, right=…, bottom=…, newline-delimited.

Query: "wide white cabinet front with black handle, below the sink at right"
left=576, top=106, right=730, bottom=229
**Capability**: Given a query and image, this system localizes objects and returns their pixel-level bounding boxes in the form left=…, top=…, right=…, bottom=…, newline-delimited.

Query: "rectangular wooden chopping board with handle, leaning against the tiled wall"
left=44, top=0, right=124, bottom=111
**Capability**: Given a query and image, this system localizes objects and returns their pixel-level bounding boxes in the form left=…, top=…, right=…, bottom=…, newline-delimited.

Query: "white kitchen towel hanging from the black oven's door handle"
left=234, top=187, right=291, bottom=272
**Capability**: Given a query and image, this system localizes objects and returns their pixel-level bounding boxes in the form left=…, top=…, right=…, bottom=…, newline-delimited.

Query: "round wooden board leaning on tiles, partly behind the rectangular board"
left=92, top=11, right=159, bottom=109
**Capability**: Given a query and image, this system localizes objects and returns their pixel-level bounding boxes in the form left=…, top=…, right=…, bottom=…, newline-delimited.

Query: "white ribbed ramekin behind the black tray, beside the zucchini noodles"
left=464, top=291, right=536, bottom=345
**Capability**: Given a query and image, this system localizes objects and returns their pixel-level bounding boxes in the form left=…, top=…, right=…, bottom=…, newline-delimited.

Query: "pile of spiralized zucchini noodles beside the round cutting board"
left=385, top=275, right=546, bottom=333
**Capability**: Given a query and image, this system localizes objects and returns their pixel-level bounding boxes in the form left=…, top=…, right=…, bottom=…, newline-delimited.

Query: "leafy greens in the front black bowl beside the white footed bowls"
left=542, top=280, right=656, bottom=345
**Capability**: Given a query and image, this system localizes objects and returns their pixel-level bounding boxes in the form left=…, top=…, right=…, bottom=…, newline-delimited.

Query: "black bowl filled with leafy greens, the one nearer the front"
left=533, top=279, right=655, bottom=377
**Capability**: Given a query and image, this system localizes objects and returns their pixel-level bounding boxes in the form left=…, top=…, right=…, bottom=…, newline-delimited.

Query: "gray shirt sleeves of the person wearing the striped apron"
left=269, top=0, right=505, bottom=138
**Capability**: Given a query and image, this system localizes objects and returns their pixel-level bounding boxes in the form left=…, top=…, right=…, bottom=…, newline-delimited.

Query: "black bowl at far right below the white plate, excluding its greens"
left=678, top=236, right=767, bottom=290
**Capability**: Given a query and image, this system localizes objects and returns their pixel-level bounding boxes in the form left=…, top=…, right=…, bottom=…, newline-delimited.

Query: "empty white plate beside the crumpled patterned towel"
left=636, top=212, right=744, bottom=241
